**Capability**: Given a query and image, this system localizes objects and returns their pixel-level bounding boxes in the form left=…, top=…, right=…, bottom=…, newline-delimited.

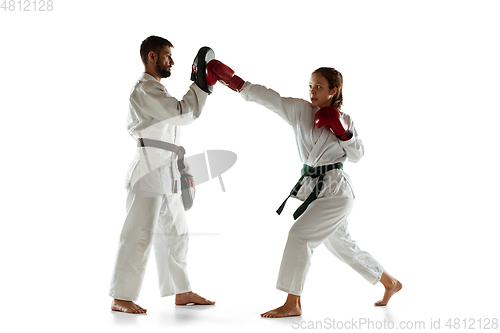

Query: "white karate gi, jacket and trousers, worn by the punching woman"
left=240, top=82, right=384, bottom=296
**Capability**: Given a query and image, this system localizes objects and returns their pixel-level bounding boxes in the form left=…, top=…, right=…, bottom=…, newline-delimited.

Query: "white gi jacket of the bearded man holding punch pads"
left=125, top=73, right=208, bottom=195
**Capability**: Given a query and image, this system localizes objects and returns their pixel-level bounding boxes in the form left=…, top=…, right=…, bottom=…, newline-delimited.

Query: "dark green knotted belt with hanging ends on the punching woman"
left=276, top=162, right=343, bottom=220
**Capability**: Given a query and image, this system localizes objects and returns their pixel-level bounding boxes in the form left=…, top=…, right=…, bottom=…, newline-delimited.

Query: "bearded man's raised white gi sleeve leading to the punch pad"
left=130, top=81, right=208, bottom=126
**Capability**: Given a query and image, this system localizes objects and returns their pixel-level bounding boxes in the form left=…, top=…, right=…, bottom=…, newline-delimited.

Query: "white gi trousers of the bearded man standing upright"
left=109, top=189, right=191, bottom=301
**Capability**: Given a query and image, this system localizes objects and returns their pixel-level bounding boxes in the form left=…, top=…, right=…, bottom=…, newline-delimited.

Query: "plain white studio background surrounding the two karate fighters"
left=0, top=0, right=500, bottom=332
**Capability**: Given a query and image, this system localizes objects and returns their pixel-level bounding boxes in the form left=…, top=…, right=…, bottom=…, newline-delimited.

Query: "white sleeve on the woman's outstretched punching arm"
left=240, top=81, right=307, bottom=125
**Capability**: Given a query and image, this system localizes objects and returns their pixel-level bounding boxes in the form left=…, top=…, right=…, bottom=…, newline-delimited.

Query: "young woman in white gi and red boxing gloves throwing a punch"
left=207, top=60, right=403, bottom=318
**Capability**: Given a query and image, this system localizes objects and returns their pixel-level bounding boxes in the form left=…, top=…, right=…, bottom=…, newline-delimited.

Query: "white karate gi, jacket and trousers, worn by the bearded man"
left=109, top=73, right=208, bottom=301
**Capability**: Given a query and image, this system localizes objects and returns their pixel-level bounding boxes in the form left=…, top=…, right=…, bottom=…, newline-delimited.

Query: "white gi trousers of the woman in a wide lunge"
left=276, top=189, right=384, bottom=296
